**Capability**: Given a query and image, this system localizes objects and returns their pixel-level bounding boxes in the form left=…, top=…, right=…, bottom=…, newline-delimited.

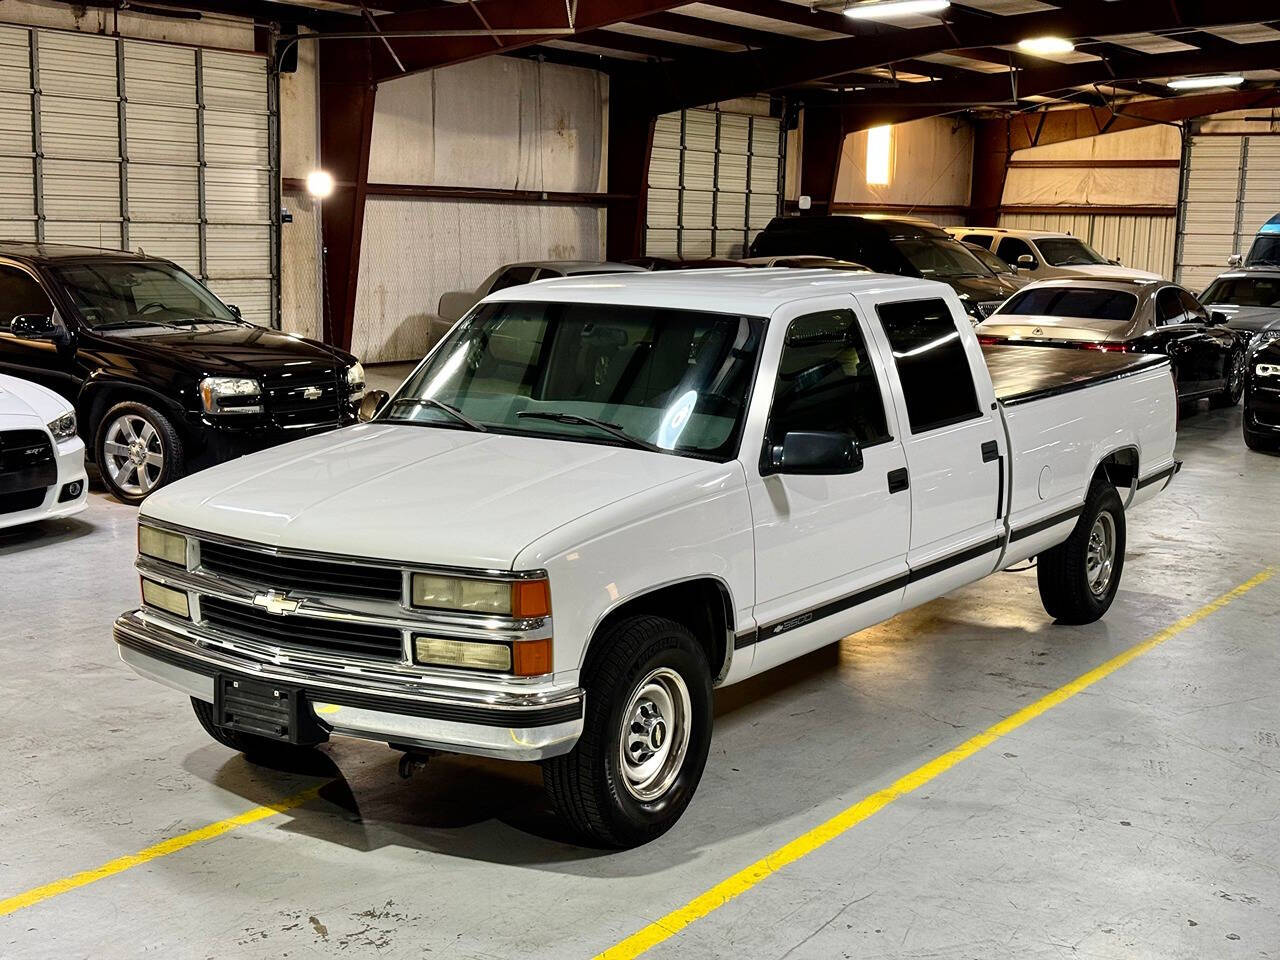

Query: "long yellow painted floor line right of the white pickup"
left=594, top=567, right=1276, bottom=960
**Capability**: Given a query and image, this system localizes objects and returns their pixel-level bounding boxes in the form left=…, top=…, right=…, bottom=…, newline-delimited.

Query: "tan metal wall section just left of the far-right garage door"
left=1000, top=124, right=1181, bottom=276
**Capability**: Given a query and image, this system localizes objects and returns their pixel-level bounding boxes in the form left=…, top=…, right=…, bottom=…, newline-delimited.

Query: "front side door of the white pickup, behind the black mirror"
left=744, top=302, right=911, bottom=672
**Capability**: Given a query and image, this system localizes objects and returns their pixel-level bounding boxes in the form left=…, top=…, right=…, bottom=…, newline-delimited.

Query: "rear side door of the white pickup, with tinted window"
left=864, top=297, right=1007, bottom=607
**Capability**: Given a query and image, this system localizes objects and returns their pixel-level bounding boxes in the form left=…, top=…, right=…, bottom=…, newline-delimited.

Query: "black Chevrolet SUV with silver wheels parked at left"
left=0, top=243, right=365, bottom=503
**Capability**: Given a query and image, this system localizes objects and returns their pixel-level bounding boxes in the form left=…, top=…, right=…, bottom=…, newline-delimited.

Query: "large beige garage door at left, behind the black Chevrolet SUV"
left=0, top=27, right=279, bottom=325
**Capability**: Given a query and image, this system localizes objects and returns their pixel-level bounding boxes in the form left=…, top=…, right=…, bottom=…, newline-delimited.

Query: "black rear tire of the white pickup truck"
left=1036, top=477, right=1125, bottom=623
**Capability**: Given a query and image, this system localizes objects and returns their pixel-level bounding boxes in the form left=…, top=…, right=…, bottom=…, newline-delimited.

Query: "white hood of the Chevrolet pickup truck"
left=141, top=424, right=723, bottom=570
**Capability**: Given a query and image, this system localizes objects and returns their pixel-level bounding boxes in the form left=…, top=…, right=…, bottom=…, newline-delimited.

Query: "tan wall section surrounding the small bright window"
left=835, top=118, right=973, bottom=225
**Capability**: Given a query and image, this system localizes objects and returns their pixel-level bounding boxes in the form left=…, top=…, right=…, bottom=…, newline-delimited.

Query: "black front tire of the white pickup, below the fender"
left=543, top=616, right=712, bottom=847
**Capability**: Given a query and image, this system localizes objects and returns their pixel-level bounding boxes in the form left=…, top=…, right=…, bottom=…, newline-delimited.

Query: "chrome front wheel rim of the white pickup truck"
left=618, top=667, right=692, bottom=803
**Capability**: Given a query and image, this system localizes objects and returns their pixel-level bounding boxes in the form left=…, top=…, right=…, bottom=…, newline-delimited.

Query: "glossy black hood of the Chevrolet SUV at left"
left=90, top=324, right=353, bottom=376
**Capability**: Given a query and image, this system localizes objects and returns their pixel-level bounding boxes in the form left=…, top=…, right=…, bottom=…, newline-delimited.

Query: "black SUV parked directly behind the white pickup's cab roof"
left=751, top=214, right=1027, bottom=324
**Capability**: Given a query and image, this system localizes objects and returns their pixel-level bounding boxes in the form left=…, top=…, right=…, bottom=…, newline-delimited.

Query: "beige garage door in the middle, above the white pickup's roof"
left=645, top=103, right=783, bottom=259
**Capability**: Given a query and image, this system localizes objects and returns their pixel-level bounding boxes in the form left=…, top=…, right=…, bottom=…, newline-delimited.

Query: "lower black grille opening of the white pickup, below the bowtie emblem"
left=200, top=596, right=404, bottom=660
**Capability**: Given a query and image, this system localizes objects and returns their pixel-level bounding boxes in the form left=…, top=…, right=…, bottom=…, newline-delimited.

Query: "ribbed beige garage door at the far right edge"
left=1176, top=136, right=1280, bottom=291
